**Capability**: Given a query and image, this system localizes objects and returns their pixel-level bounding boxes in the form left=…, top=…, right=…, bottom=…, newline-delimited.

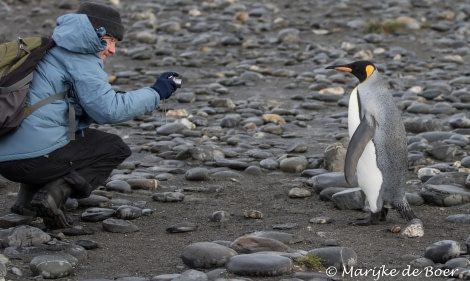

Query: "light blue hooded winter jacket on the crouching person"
left=0, top=14, right=160, bottom=162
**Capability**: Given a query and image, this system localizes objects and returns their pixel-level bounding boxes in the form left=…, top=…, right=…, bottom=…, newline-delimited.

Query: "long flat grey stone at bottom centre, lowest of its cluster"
left=226, top=254, right=292, bottom=276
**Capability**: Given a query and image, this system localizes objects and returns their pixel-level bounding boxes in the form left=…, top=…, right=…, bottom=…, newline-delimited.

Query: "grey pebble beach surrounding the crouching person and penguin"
left=0, top=0, right=470, bottom=281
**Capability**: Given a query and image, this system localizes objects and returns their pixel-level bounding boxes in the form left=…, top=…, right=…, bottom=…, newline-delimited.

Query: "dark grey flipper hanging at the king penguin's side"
left=344, top=118, right=375, bottom=184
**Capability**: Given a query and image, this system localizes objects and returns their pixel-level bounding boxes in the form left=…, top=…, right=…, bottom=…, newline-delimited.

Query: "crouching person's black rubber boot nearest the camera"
left=31, top=178, right=72, bottom=229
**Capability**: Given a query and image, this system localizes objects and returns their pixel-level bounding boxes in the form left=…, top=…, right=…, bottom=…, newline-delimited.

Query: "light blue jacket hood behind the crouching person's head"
left=52, top=14, right=106, bottom=54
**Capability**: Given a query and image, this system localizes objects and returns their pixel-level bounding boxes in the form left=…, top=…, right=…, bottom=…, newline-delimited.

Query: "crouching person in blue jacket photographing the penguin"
left=0, top=2, right=179, bottom=229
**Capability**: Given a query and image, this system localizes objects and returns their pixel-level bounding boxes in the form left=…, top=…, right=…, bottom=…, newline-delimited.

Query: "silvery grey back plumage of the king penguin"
left=358, top=70, right=408, bottom=203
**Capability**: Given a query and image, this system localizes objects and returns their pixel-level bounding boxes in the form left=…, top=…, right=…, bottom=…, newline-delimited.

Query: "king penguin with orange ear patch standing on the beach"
left=327, top=61, right=416, bottom=225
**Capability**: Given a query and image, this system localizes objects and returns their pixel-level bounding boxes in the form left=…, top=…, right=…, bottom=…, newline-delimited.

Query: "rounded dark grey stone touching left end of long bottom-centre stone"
left=181, top=242, right=237, bottom=269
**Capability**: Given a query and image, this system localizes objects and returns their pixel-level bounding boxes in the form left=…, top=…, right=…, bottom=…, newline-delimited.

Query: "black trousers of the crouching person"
left=0, top=128, right=131, bottom=198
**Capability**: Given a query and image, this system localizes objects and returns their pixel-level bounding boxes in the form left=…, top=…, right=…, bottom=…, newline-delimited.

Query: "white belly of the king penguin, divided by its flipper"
left=348, top=88, right=383, bottom=212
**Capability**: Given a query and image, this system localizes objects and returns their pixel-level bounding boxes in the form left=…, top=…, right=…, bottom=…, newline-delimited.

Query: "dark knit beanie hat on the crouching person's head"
left=77, top=2, right=124, bottom=41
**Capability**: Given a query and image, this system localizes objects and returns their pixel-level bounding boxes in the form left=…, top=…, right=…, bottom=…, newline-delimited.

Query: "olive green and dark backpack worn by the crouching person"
left=0, top=37, right=75, bottom=139
